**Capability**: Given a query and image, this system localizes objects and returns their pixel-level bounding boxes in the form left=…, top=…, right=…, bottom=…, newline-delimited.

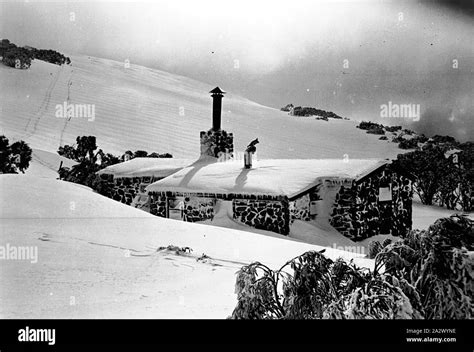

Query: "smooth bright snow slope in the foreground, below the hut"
left=0, top=175, right=372, bottom=318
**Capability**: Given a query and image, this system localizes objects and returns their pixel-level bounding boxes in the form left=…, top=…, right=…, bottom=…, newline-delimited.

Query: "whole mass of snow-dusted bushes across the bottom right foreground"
left=231, top=216, right=474, bottom=319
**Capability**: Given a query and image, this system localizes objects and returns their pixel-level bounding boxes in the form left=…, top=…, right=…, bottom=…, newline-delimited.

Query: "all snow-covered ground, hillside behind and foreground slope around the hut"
left=0, top=56, right=470, bottom=318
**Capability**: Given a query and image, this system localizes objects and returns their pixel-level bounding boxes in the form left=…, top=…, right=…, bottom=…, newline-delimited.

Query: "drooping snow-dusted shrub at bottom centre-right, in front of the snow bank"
left=231, top=251, right=420, bottom=319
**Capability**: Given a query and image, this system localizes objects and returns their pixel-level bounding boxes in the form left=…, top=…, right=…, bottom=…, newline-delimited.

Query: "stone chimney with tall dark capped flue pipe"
left=200, top=87, right=234, bottom=160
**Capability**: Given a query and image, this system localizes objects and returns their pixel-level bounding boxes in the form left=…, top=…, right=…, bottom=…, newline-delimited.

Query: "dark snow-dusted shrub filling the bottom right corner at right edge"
left=376, top=215, right=474, bottom=319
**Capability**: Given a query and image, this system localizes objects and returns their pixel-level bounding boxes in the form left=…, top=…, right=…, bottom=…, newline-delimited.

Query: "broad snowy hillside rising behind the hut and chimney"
left=0, top=56, right=400, bottom=159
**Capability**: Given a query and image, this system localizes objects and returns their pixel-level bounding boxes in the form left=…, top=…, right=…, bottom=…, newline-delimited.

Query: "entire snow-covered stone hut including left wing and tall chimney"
left=95, top=87, right=413, bottom=241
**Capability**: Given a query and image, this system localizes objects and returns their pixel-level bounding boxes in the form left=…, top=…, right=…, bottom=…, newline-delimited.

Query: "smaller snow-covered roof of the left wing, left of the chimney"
left=97, top=158, right=195, bottom=177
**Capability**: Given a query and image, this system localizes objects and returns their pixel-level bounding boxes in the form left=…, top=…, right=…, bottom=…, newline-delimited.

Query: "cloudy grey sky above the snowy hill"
left=0, top=0, right=474, bottom=140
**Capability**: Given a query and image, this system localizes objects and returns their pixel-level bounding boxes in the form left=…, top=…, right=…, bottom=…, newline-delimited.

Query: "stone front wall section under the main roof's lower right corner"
left=232, top=199, right=290, bottom=235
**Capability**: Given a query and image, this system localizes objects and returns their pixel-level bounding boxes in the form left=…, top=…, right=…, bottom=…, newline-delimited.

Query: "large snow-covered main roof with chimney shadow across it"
left=146, top=159, right=388, bottom=198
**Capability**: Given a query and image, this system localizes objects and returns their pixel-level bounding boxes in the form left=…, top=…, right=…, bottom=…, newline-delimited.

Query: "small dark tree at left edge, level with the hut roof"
left=0, top=136, right=32, bottom=174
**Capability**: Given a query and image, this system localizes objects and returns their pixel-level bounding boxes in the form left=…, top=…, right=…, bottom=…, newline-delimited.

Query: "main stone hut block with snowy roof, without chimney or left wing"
left=146, top=159, right=412, bottom=240
